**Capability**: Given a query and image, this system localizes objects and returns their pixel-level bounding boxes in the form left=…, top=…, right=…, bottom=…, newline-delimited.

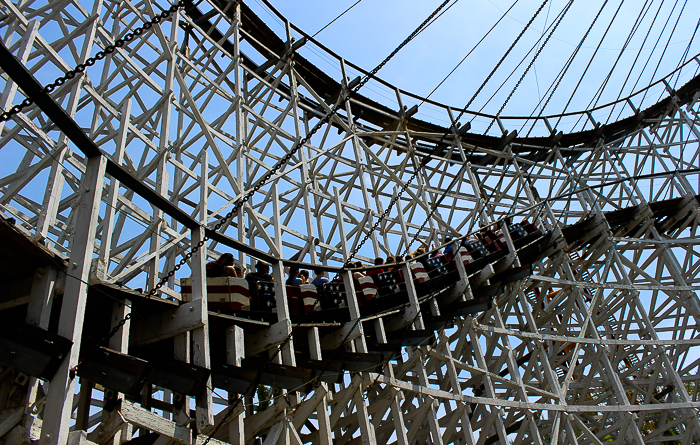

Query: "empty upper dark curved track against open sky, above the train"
left=193, top=0, right=700, bottom=165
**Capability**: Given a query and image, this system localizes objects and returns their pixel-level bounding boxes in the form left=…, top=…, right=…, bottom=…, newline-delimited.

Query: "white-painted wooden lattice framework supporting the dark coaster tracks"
left=0, top=0, right=700, bottom=443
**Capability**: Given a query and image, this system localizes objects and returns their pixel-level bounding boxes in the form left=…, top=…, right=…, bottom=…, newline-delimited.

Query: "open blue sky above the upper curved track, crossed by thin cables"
left=246, top=0, right=700, bottom=125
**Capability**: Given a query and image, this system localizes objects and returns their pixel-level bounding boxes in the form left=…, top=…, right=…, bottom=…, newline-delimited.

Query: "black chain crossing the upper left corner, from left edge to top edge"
left=0, top=0, right=192, bottom=122
